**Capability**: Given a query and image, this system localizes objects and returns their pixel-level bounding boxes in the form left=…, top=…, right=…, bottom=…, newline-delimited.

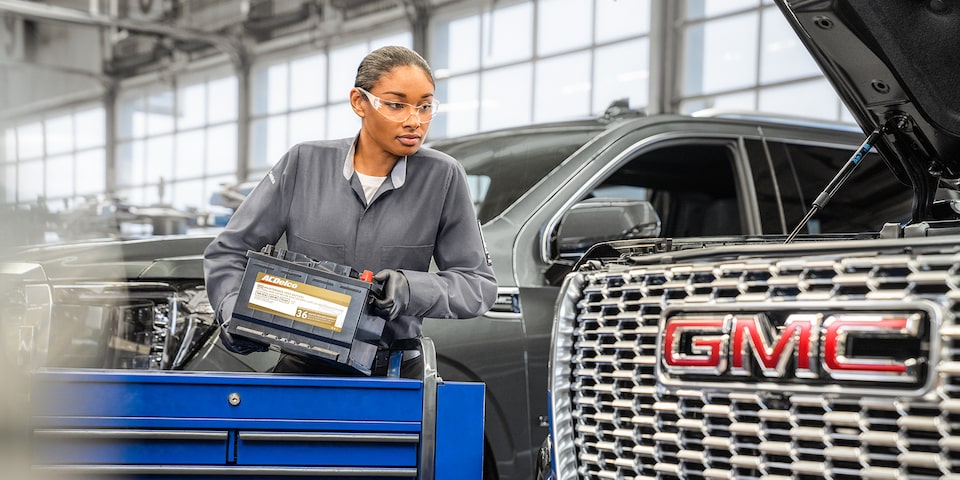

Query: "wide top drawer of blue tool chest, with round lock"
left=31, top=369, right=423, bottom=426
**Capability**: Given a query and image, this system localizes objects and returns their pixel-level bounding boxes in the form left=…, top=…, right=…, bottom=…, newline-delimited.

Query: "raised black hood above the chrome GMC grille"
left=776, top=0, right=960, bottom=223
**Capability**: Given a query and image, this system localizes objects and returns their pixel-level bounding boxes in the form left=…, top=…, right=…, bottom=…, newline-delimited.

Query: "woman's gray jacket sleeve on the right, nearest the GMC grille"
left=403, top=163, right=497, bottom=318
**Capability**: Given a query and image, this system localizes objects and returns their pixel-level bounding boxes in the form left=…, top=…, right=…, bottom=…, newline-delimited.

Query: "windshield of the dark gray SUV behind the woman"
left=431, top=128, right=601, bottom=223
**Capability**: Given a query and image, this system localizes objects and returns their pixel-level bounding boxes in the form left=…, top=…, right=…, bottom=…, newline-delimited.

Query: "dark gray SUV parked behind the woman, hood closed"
left=0, top=105, right=911, bottom=479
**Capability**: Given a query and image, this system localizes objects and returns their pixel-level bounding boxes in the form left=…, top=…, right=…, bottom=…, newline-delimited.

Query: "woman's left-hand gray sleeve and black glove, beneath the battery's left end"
left=203, top=147, right=297, bottom=354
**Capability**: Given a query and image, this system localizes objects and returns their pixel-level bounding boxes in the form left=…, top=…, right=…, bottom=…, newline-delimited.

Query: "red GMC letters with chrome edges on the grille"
left=662, top=313, right=922, bottom=382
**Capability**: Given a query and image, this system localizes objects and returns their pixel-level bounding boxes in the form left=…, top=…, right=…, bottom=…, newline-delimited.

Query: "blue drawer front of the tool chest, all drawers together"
left=31, top=370, right=423, bottom=476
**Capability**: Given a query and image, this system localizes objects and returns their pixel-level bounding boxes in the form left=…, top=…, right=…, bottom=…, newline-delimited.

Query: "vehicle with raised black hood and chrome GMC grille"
left=538, top=0, right=960, bottom=480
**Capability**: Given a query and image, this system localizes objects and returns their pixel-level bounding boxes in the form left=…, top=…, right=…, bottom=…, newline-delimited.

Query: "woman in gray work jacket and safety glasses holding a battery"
left=204, top=46, right=496, bottom=377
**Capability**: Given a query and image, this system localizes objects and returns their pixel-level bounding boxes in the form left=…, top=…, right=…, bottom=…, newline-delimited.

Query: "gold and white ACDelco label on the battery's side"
left=247, top=272, right=351, bottom=332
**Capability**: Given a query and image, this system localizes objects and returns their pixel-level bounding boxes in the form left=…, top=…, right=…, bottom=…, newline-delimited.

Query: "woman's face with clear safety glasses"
left=350, top=65, right=434, bottom=157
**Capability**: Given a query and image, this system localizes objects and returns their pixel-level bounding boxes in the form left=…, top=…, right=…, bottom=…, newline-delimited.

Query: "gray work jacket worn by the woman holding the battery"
left=203, top=138, right=497, bottom=346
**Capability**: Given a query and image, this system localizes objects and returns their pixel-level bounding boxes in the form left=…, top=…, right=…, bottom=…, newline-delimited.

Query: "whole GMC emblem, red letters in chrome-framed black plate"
left=658, top=303, right=933, bottom=388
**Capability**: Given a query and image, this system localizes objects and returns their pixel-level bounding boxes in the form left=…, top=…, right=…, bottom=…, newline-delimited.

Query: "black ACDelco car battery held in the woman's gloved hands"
left=227, top=245, right=385, bottom=375
